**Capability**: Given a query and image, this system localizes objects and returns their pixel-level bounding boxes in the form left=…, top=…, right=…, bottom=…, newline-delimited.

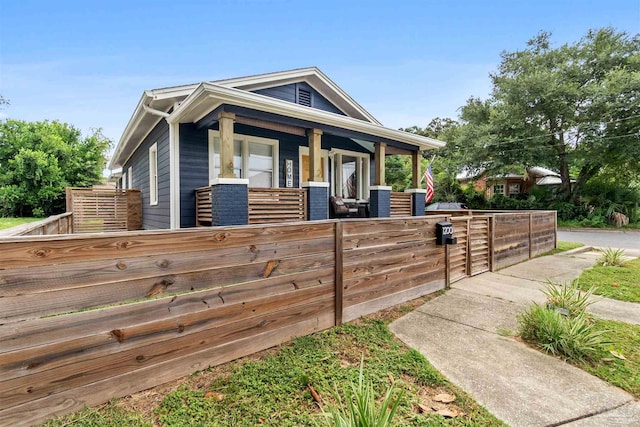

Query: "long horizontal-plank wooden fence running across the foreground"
left=0, top=215, right=555, bottom=425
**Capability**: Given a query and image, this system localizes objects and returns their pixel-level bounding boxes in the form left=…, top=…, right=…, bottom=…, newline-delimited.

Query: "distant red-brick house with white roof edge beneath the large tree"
left=456, top=166, right=562, bottom=198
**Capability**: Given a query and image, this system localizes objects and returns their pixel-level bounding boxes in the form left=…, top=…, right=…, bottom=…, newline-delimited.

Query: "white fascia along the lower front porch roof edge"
left=167, top=83, right=445, bottom=150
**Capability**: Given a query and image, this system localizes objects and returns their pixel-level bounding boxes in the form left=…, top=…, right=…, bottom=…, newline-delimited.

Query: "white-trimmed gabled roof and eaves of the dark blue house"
left=109, top=67, right=444, bottom=169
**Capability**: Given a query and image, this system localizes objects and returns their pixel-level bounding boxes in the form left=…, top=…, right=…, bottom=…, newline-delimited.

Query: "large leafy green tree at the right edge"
left=451, top=28, right=640, bottom=202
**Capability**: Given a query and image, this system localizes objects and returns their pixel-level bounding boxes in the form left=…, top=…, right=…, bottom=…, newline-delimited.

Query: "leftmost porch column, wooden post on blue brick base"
left=211, top=111, right=249, bottom=226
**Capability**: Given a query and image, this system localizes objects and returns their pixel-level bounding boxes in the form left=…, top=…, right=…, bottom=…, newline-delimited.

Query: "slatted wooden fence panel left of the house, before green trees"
left=66, top=187, right=142, bottom=233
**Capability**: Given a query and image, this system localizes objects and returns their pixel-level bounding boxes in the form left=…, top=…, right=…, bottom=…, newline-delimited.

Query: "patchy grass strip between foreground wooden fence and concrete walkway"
left=42, top=308, right=504, bottom=427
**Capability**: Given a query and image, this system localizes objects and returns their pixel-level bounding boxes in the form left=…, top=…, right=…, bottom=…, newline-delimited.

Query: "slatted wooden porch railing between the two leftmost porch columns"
left=249, top=188, right=307, bottom=224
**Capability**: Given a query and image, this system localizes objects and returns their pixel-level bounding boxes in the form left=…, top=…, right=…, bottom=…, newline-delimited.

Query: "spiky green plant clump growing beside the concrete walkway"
left=518, top=283, right=610, bottom=362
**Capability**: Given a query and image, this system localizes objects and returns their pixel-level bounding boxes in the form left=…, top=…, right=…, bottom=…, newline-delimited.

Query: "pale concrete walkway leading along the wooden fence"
left=390, top=252, right=640, bottom=427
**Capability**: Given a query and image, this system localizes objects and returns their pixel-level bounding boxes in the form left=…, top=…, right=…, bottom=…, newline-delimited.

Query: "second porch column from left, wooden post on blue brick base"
left=302, top=129, right=329, bottom=221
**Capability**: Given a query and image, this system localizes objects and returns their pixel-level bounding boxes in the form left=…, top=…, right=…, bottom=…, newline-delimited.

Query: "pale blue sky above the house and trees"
left=0, top=0, right=640, bottom=167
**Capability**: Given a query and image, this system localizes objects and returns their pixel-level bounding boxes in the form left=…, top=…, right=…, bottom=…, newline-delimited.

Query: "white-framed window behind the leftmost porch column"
left=209, top=130, right=279, bottom=188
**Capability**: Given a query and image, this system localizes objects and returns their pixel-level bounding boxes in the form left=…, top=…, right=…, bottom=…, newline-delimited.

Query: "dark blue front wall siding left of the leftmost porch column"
left=180, top=123, right=209, bottom=227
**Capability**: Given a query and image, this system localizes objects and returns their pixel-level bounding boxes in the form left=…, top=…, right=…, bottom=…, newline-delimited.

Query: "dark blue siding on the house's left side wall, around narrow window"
left=122, top=119, right=170, bottom=230
